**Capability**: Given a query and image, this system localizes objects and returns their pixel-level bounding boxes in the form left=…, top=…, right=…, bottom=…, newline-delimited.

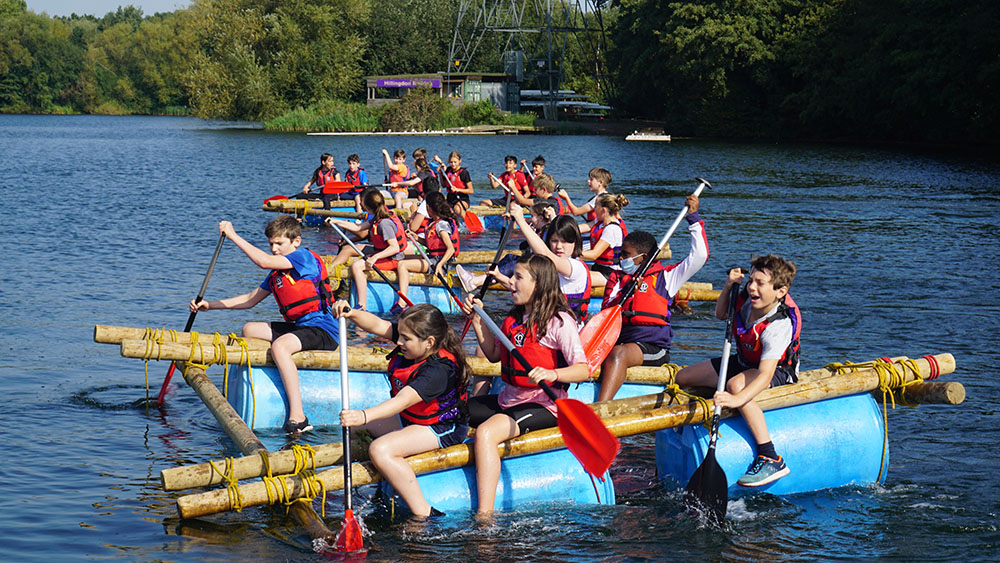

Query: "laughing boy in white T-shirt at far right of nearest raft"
left=677, top=254, right=802, bottom=487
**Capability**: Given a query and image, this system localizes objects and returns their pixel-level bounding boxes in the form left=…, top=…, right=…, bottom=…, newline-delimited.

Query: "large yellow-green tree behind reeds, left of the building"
left=185, top=0, right=369, bottom=119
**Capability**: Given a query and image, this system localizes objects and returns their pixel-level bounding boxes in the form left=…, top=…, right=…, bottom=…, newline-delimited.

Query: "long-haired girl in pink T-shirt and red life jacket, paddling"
left=463, top=255, right=590, bottom=516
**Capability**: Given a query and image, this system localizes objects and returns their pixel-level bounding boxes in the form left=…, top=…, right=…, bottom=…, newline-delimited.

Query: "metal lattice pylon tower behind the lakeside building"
left=448, top=0, right=610, bottom=119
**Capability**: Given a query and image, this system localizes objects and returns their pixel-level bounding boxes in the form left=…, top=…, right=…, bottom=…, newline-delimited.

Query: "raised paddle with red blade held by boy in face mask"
left=580, top=178, right=712, bottom=373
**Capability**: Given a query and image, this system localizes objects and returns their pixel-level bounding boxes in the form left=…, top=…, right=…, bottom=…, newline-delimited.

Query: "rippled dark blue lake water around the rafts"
left=0, top=116, right=1000, bottom=561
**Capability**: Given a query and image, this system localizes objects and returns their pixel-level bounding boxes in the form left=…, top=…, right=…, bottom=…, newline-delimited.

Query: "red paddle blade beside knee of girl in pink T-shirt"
left=556, top=399, right=621, bottom=479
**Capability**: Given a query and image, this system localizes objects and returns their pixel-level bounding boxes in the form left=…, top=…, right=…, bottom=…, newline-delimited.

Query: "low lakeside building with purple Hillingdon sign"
left=365, top=72, right=521, bottom=112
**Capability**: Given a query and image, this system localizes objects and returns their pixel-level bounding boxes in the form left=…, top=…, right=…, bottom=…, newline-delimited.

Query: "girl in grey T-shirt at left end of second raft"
left=327, top=189, right=407, bottom=313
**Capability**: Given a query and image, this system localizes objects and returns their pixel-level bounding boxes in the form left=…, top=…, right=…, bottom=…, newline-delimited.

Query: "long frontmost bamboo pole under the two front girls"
left=177, top=354, right=955, bottom=518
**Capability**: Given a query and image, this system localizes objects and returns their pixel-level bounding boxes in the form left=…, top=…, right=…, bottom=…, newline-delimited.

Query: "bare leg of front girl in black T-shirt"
left=368, top=424, right=438, bottom=516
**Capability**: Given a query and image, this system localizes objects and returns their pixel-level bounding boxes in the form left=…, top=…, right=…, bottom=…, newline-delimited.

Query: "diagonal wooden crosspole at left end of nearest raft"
left=178, top=365, right=333, bottom=539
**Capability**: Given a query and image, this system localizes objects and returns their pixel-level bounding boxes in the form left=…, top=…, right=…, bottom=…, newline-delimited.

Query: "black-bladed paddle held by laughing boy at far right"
left=684, top=283, right=740, bottom=524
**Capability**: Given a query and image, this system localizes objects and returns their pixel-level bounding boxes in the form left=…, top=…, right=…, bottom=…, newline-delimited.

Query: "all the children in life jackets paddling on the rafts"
left=190, top=151, right=801, bottom=516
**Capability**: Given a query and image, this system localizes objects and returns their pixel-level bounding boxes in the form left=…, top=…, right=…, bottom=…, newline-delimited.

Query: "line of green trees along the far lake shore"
left=0, top=0, right=1000, bottom=144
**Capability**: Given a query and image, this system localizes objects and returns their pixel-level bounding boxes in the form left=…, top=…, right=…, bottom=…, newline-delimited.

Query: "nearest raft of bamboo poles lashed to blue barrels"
left=95, top=327, right=965, bottom=518
